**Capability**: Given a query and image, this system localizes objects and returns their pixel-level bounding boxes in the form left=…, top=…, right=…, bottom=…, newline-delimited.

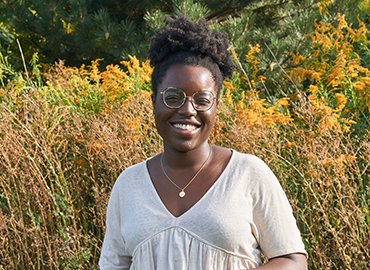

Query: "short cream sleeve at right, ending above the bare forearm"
left=253, top=156, right=307, bottom=259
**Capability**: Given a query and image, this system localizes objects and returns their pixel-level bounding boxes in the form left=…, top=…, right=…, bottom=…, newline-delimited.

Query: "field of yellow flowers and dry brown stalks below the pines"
left=0, top=15, right=370, bottom=269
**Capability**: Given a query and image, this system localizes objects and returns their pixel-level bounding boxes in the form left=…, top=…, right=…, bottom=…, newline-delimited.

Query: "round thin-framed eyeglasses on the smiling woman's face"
left=159, top=87, right=216, bottom=112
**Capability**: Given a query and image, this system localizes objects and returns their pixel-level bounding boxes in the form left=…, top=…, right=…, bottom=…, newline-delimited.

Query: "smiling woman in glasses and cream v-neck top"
left=99, top=16, right=307, bottom=270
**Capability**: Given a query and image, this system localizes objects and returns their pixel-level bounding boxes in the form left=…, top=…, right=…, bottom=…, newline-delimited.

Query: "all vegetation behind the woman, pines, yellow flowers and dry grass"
left=0, top=0, right=370, bottom=269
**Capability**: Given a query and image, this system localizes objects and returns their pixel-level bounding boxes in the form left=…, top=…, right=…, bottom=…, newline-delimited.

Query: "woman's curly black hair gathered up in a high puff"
left=148, top=16, right=237, bottom=96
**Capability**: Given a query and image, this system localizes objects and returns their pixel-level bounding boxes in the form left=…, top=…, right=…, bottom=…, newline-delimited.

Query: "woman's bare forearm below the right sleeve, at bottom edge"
left=256, top=253, right=308, bottom=270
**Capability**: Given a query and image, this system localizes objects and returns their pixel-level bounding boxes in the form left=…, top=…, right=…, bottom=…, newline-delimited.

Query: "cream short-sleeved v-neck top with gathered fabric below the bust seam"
left=99, top=150, right=307, bottom=270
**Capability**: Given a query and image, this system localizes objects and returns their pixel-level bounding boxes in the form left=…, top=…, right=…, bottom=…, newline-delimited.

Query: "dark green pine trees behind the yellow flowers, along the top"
left=0, top=0, right=370, bottom=124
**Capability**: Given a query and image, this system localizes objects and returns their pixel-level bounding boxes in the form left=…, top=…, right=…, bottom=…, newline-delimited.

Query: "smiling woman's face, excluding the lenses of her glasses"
left=152, top=65, right=218, bottom=151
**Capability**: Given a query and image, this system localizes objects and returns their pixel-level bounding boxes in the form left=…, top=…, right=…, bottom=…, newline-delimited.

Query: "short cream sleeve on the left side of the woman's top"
left=99, top=182, right=131, bottom=270
